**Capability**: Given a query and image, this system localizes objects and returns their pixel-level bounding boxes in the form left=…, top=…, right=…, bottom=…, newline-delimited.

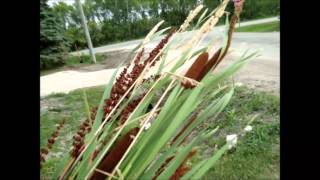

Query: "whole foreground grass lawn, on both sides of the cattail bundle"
left=40, top=87, right=280, bottom=180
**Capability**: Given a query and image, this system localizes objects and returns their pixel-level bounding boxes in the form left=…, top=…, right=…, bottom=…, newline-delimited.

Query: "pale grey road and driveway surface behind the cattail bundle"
left=40, top=18, right=280, bottom=96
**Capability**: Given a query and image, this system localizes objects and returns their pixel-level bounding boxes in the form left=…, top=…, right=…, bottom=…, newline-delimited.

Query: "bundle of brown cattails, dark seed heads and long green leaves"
left=43, top=0, right=257, bottom=180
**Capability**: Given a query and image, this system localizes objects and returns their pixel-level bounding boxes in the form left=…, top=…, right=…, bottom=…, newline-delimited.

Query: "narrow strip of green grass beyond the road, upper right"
left=236, top=21, right=280, bottom=32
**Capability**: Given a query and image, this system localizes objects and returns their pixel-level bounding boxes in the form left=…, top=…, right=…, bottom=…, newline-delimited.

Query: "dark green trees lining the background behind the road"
left=41, top=0, right=280, bottom=67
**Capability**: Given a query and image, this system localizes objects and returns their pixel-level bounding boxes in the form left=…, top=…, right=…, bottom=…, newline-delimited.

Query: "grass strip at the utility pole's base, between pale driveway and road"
left=40, top=53, right=107, bottom=76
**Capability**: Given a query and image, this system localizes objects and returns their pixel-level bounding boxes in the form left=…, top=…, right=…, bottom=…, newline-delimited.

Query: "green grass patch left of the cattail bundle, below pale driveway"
left=40, top=87, right=104, bottom=179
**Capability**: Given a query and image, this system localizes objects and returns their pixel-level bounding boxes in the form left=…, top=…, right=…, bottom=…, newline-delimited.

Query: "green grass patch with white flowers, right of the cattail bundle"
left=199, top=87, right=280, bottom=180
